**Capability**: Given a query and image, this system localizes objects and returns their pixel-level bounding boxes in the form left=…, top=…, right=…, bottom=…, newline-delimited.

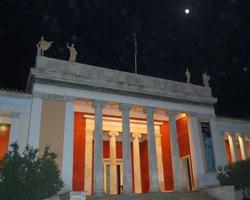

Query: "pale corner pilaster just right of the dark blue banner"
left=209, top=116, right=226, bottom=170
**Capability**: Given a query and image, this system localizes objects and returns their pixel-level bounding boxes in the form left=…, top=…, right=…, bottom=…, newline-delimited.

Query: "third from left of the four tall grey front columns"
left=145, top=107, right=159, bottom=192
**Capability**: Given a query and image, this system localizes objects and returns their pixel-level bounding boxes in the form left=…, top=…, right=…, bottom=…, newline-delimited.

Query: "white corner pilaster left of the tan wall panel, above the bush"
left=28, top=97, right=42, bottom=148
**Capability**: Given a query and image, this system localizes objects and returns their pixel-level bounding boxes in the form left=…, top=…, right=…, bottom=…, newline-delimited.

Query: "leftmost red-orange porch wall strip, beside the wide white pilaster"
left=73, top=112, right=86, bottom=191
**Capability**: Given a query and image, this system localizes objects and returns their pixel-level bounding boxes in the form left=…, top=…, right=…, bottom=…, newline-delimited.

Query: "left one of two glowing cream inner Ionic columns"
left=109, top=132, right=119, bottom=194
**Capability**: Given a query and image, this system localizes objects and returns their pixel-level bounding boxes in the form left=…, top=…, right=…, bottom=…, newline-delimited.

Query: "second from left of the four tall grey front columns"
left=120, top=104, right=132, bottom=193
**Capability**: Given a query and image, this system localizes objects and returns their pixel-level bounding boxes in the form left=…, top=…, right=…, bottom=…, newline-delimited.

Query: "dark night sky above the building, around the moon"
left=0, top=0, right=250, bottom=118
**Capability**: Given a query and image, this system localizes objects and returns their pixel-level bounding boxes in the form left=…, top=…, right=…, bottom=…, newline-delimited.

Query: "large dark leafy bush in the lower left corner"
left=0, top=143, right=63, bottom=200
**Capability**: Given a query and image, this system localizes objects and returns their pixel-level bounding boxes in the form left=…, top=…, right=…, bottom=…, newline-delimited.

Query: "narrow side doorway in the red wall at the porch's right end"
left=181, top=156, right=193, bottom=191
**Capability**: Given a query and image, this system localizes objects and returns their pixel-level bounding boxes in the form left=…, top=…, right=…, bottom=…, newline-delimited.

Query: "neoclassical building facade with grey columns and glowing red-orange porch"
left=0, top=56, right=250, bottom=195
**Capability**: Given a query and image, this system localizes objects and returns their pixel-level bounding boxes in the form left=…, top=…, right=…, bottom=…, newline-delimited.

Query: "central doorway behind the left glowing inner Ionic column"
left=104, top=159, right=123, bottom=194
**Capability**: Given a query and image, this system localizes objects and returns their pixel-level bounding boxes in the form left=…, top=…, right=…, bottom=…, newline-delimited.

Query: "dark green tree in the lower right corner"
left=217, top=159, right=250, bottom=199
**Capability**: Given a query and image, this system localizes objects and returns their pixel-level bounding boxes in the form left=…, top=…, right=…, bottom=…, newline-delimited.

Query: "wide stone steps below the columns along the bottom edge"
left=87, top=191, right=215, bottom=200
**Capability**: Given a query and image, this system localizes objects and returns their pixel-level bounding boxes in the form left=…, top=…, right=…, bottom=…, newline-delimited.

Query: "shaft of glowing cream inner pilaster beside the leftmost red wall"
left=84, top=130, right=93, bottom=194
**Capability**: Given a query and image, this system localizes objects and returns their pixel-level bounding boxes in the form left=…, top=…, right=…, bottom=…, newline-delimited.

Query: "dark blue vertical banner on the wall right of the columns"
left=200, top=122, right=215, bottom=172
